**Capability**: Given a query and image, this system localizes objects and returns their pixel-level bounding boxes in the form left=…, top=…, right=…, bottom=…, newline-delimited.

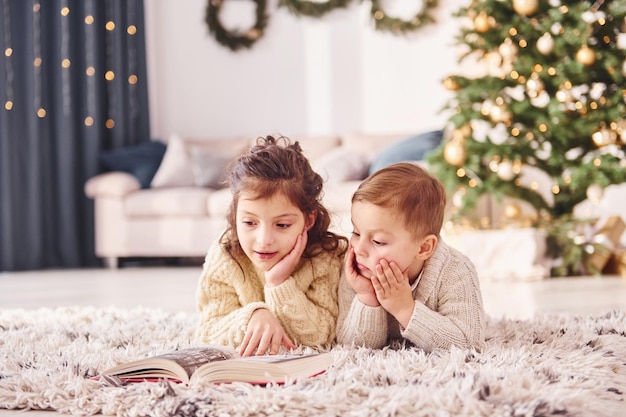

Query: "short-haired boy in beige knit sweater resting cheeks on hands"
left=337, top=162, right=485, bottom=352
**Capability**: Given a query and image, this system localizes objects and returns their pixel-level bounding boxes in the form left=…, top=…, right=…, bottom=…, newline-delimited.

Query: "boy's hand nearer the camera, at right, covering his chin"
left=372, top=259, right=415, bottom=328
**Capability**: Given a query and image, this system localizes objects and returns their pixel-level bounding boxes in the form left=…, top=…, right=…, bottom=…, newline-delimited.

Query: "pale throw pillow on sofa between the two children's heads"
left=312, top=147, right=369, bottom=183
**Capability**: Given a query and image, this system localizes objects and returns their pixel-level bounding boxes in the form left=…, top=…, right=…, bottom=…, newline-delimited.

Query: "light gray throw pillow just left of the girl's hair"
left=191, top=147, right=235, bottom=188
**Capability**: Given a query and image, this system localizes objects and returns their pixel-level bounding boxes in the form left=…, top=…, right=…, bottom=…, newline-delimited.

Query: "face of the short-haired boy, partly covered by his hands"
left=350, top=201, right=424, bottom=279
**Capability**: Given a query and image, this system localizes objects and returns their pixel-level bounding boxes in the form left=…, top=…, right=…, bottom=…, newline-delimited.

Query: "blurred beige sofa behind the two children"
left=85, top=134, right=410, bottom=267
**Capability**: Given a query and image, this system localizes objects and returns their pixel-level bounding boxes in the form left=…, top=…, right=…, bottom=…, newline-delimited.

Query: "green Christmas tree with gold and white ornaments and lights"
left=429, top=0, right=626, bottom=275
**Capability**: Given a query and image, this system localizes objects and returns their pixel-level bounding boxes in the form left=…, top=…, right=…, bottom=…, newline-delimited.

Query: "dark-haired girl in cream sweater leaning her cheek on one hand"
left=196, top=136, right=347, bottom=356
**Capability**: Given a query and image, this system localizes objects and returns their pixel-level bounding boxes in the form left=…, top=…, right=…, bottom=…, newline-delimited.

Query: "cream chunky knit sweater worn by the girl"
left=196, top=237, right=345, bottom=347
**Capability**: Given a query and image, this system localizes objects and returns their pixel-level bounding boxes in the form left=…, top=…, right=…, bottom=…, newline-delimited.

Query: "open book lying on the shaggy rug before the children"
left=100, top=345, right=332, bottom=385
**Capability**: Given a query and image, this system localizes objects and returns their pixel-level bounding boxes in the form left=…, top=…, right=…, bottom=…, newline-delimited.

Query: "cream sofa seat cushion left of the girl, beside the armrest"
left=124, top=187, right=212, bottom=217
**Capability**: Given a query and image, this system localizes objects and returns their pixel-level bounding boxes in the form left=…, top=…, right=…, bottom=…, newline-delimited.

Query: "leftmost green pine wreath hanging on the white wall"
left=205, top=0, right=268, bottom=51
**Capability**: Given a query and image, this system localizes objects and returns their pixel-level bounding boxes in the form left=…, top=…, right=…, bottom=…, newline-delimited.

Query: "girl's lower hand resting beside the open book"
left=239, top=308, right=297, bottom=357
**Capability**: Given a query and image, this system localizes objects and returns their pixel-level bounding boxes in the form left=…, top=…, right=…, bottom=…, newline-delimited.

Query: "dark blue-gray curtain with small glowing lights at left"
left=0, top=0, right=150, bottom=271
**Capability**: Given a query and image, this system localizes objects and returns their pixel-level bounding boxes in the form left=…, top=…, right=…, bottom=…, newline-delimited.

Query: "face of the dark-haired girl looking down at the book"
left=236, top=192, right=314, bottom=271
